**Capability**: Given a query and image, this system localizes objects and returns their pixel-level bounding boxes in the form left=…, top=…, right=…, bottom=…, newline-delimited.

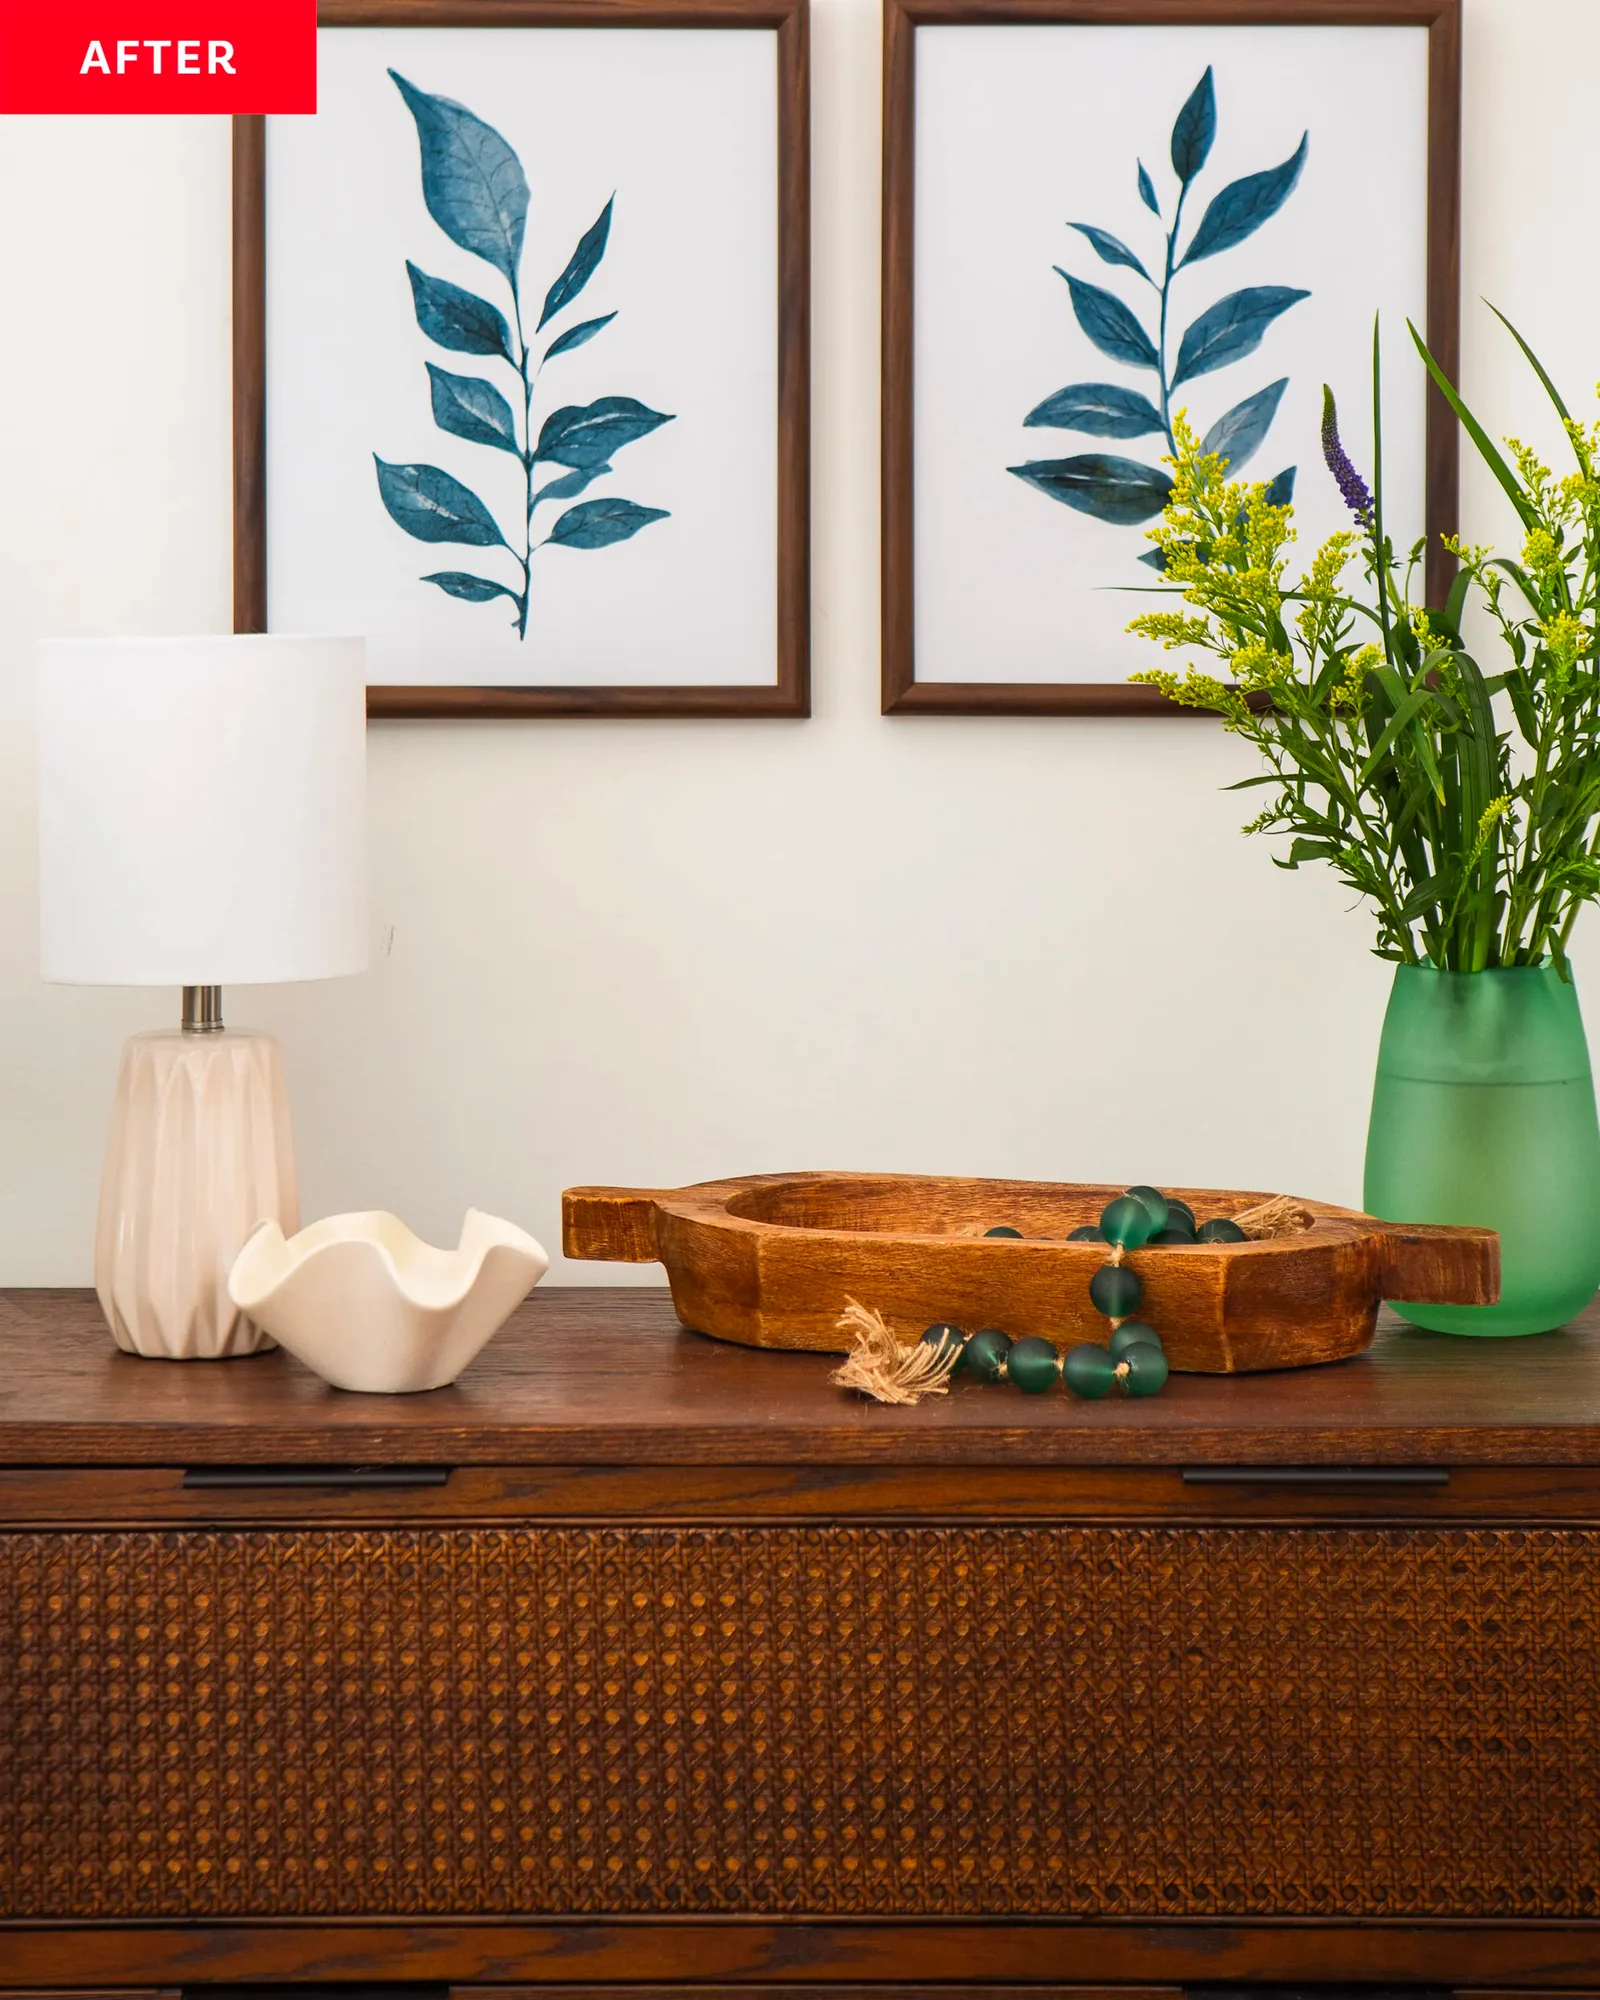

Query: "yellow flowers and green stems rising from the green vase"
left=1130, top=314, right=1600, bottom=978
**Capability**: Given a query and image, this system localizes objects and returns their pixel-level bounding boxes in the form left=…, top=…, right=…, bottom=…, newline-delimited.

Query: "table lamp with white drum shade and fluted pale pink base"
left=38, top=634, right=366, bottom=1360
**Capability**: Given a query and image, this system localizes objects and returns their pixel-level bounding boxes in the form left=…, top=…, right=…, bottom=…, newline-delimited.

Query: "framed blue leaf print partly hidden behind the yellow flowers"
left=882, top=0, right=1460, bottom=714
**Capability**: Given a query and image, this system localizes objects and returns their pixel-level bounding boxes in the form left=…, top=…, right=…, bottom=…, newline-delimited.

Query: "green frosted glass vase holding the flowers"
left=1364, top=966, right=1600, bottom=1334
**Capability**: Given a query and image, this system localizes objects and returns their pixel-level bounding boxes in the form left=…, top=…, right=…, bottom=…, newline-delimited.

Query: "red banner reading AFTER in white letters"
left=0, top=0, right=316, bottom=114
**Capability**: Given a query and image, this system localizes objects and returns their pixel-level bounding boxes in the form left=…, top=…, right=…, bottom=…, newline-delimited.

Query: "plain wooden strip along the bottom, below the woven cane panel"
left=0, top=1920, right=1600, bottom=2000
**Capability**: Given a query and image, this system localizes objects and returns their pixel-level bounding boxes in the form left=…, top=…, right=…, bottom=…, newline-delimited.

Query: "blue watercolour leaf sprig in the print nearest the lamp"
left=374, top=70, right=674, bottom=640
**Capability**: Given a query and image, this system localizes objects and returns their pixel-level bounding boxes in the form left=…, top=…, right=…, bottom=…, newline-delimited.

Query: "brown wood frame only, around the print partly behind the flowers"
left=882, top=0, right=1462, bottom=716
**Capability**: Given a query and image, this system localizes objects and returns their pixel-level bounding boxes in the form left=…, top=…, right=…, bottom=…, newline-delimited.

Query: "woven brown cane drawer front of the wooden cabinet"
left=0, top=1526, right=1600, bottom=1918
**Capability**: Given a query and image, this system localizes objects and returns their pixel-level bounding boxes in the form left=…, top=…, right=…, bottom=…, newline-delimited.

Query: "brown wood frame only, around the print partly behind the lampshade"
left=234, top=0, right=810, bottom=718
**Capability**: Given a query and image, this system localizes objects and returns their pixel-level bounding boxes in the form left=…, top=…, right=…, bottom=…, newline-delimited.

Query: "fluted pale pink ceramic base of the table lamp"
left=94, top=1034, right=300, bottom=1360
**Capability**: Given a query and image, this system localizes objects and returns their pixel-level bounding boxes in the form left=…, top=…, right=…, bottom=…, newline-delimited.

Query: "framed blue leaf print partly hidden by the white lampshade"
left=234, top=0, right=808, bottom=716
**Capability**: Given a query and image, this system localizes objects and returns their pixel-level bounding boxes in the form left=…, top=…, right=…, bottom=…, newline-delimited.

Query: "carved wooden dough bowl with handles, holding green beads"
left=562, top=1174, right=1500, bottom=1374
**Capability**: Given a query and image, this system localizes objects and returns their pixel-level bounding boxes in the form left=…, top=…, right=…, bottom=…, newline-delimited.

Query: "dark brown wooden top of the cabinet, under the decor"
left=0, top=1288, right=1600, bottom=1468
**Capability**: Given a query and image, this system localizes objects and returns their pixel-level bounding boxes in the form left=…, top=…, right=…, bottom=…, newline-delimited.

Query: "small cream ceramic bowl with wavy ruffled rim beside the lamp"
left=228, top=1208, right=550, bottom=1396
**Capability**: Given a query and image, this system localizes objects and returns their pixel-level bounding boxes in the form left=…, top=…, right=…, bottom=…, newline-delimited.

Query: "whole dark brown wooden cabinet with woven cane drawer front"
left=0, top=1292, right=1600, bottom=2000
